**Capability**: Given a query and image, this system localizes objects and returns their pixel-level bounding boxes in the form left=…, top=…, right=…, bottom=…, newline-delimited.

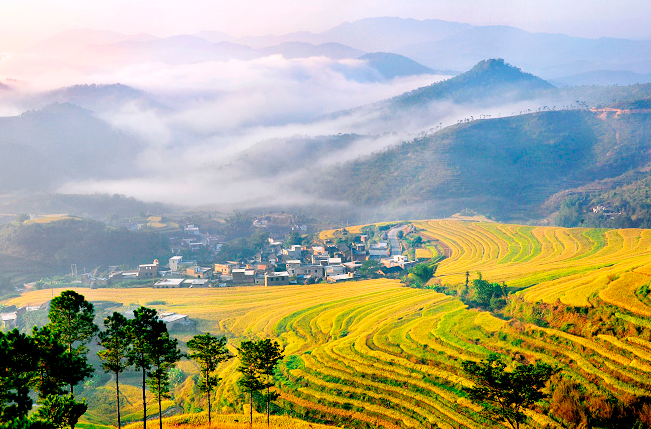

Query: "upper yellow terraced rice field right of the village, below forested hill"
left=414, top=221, right=651, bottom=316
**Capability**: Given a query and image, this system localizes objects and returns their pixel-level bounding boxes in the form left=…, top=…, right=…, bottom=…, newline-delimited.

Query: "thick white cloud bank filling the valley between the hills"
left=0, top=46, right=458, bottom=207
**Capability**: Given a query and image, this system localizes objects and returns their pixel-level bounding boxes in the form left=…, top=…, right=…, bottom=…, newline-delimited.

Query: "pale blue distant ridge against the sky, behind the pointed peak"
left=191, top=17, right=651, bottom=79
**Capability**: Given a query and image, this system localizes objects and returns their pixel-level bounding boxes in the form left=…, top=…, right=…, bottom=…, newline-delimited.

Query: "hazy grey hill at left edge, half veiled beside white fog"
left=0, top=103, right=143, bottom=192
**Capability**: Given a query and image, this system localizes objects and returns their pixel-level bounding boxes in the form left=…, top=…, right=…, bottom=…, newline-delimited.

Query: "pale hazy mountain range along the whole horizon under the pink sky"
left=25, top=17, right=651, bottom=84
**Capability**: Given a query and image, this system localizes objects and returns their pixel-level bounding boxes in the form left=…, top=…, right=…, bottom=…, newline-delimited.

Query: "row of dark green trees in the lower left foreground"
left=0, top=290, right=283, bottom=429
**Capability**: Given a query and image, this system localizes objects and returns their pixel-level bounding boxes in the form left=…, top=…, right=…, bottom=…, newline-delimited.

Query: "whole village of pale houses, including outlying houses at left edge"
left=0, top=220, right=426, bottom=331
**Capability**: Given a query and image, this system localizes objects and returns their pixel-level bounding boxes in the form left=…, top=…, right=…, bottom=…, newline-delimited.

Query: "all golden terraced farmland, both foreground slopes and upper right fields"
left=6, top=221, right=651, bottom=429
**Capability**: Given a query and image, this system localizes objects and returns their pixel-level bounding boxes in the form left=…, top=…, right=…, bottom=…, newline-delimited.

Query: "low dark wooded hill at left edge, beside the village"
left=0, top=218, right=169, bottom=293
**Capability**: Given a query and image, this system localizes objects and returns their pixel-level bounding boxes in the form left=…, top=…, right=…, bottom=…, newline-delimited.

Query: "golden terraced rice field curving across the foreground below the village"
left=8, top=274, right=651, bottom=429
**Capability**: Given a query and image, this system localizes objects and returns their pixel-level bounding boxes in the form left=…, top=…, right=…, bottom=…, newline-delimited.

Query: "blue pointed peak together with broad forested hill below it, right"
left=177, top=60, right=651, bottom=222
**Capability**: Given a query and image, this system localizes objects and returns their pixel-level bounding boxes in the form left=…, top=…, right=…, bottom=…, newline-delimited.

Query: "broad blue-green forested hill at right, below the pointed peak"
left=313, top=110, right=651, bottom=220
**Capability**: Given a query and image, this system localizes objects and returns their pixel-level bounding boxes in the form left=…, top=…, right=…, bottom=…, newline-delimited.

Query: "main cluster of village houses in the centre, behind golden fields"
left=102, top=220, right=416, bottom=288
